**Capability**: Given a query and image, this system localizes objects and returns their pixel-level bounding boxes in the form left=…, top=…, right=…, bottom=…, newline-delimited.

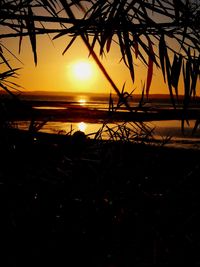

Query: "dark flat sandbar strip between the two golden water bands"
left=4, top=101, right=200, bottom=122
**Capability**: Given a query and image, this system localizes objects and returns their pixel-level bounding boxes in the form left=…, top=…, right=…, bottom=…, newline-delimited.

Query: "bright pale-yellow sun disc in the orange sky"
left=71, top=61, right=93, bottom=81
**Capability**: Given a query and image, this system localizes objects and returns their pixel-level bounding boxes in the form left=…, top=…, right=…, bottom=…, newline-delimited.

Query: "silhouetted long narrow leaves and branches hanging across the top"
left=0, top=0, right=200, bottom=131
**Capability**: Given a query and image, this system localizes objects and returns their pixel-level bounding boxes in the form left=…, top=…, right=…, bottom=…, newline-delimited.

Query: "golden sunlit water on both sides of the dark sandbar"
left=9, top=91, right=200, bottom=149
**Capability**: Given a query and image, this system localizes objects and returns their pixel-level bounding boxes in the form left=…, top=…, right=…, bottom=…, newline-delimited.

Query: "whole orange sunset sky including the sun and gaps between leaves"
left=0, top=0, right=198, bottom=97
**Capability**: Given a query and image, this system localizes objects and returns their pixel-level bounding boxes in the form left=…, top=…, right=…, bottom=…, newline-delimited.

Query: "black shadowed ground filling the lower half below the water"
left=0, top=129, right=200, bottom=267
